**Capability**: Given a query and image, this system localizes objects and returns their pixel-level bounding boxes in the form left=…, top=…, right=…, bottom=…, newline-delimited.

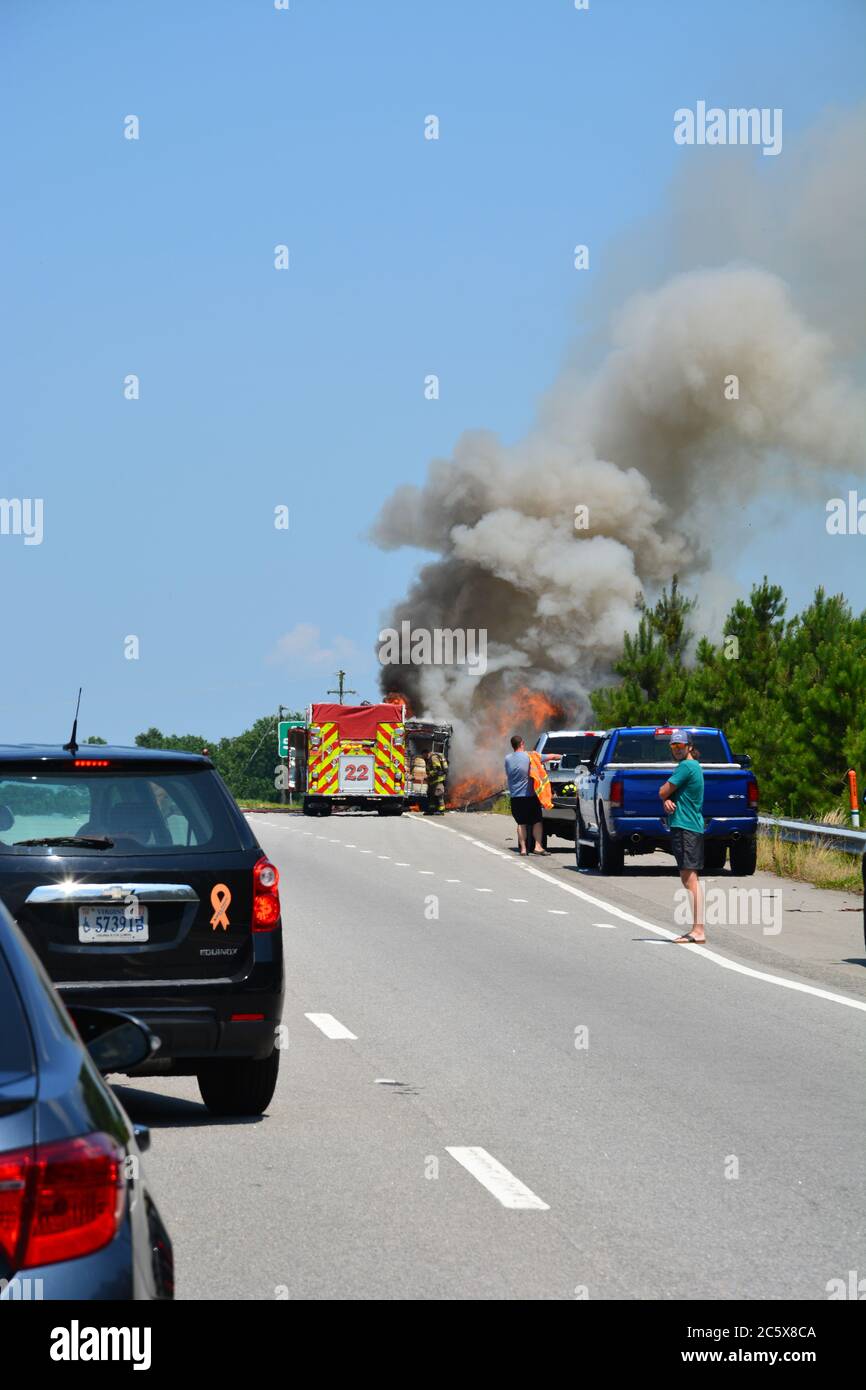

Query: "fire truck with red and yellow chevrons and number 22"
left=303, top=703, right=452, bottom=816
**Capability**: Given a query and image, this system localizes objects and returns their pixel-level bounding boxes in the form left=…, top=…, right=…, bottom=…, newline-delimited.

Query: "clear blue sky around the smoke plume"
left=0, top=0, right=866, bottom=742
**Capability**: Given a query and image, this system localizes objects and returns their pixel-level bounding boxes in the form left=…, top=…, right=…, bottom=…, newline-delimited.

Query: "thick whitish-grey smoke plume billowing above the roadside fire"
left=373, top=113, right=866, bottom=795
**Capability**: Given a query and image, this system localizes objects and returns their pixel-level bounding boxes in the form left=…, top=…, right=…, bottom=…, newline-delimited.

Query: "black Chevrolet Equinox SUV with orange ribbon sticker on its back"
left=0, top=744, right=284, bottom=1115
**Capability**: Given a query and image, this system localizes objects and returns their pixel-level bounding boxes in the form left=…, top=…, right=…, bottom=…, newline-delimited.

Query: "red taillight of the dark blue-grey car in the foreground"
left=0, top=1134, right=125, bottom=1270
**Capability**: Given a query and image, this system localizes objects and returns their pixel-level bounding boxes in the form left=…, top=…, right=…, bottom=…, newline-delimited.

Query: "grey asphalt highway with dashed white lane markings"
left=117, top=815, right=866, bottom=1300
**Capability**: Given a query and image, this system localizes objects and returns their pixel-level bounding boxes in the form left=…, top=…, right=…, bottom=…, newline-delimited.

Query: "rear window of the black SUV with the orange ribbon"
left=0, top=763, right=242, bottom=858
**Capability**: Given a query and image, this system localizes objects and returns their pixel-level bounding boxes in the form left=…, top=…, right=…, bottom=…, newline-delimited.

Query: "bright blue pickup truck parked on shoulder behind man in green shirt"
left=574, top=724, right=758, bottom=876
